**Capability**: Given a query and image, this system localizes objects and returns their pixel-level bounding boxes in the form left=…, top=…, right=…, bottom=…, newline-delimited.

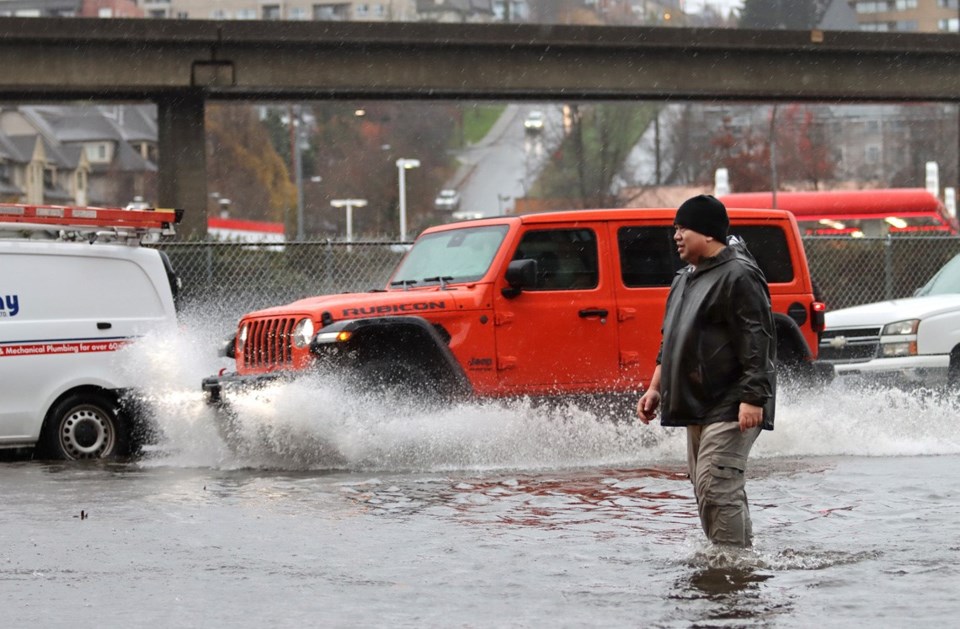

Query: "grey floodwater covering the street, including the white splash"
left=0, top=322, right=960, bottom=628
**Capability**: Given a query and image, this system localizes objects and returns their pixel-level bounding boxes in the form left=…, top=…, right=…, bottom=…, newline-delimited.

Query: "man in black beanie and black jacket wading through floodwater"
left=637, top=195, right=776, bottom=546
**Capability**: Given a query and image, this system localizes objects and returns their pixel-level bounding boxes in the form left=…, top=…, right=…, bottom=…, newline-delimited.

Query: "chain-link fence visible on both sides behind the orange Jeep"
left=159, top=237, right=960, bottom=325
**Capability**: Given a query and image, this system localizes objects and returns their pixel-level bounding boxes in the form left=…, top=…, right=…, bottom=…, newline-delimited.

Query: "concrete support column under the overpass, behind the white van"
left=156, top=90, right=207, bottom=240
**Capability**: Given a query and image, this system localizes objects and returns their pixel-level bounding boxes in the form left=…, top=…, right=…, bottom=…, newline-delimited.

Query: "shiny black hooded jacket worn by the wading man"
left=657, top=238, right=777, bottom=430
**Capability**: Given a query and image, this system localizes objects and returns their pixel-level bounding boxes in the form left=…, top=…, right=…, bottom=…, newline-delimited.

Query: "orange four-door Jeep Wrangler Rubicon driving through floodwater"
left=203, top=209, right=832, bottom=414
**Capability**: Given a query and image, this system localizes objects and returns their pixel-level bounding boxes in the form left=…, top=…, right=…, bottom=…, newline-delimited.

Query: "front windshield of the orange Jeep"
left=390, top=225, right=507, bottom=288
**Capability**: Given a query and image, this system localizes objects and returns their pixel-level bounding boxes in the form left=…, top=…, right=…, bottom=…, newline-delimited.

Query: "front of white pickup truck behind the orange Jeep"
left=820, top=255, right=960, bottom=387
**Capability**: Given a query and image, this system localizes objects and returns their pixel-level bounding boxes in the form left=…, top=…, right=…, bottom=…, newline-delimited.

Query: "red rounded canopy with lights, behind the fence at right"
left=719, top=188, right=958, bottom=238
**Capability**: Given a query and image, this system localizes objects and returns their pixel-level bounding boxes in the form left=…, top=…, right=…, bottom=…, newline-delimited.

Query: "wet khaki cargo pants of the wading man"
left=687, top=421, right=760, bottom=546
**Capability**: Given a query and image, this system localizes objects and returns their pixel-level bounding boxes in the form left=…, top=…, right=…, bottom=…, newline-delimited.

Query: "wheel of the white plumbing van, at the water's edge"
left=41, top=392, right=130, bottom=461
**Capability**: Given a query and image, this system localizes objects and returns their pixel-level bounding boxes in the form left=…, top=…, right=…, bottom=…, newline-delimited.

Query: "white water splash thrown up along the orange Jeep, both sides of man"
left=121, top=320, right=960, bottom=471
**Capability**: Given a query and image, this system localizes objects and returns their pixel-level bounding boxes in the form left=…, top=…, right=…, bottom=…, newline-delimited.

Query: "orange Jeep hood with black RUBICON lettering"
left=243, top=288, right=457, bottom=321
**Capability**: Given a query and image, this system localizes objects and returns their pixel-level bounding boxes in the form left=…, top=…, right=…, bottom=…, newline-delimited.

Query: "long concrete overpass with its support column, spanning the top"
left=0, top=18, right=960, bottom=238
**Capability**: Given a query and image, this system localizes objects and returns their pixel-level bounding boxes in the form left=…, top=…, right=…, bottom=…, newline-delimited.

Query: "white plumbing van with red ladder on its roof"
left=0, top=204, right=178, bottom=459
